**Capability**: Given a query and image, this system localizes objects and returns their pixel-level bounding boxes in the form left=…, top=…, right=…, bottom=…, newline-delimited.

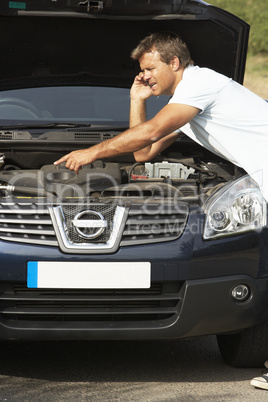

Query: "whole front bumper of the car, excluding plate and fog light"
left=0, top=215, right=268, bottom=340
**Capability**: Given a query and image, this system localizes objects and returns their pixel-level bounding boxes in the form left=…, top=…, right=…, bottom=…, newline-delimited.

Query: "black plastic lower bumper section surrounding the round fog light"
left=0, top=275, right=268, bottom=340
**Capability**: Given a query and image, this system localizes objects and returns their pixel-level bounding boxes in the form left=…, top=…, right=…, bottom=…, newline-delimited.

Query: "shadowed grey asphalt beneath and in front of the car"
left=0, top=337, right=268, bottom=402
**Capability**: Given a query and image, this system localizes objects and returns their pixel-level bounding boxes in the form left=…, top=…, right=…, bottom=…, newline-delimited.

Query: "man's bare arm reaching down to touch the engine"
left=55, top=103, right=199, bottom=173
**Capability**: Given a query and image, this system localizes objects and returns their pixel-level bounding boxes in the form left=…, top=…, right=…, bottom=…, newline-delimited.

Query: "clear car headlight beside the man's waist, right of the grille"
left=204, top=176, right=267, bottom=239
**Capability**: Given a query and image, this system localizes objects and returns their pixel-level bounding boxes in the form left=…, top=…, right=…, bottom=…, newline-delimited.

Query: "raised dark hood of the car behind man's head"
left=0, top=0, right=249, bottom=90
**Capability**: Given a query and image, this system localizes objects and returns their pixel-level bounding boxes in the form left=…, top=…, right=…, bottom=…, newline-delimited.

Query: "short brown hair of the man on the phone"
left=131, top=31, right=194, bottom=68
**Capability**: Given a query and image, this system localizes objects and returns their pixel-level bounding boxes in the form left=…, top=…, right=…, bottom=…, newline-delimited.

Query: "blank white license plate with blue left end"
left=27, top=261, right=151, bottom=289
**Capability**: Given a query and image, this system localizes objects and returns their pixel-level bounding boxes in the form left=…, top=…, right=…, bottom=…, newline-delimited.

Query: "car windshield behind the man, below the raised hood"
left=0, top=86, right=168, bottom=126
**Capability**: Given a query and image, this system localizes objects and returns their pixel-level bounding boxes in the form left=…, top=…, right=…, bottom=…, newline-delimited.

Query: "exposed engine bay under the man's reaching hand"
left=0, top=135, right=243, bottom=205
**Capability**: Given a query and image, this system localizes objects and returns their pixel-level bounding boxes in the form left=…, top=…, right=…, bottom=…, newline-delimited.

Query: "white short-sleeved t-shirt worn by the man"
left=169, top=66, right=268, bottom=201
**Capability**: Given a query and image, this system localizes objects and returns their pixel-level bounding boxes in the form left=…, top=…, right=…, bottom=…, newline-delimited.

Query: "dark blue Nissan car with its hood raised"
left=0, top=0, right=268, bottom=367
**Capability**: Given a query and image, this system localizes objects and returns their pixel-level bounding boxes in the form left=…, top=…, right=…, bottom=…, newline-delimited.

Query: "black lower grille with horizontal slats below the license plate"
left=0, top=282, right=183, bottom=327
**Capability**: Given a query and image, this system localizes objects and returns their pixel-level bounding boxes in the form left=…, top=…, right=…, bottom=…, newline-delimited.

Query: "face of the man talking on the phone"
left=139, top=49, right=177, bottom=96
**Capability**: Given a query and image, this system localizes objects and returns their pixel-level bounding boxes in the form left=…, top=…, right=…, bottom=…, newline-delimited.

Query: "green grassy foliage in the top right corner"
left=207, top=0, right=268, bottom=54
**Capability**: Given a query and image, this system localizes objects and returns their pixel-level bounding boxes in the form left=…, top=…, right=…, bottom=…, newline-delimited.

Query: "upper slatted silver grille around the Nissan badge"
left=0, top=202, right=188, bottom=246
